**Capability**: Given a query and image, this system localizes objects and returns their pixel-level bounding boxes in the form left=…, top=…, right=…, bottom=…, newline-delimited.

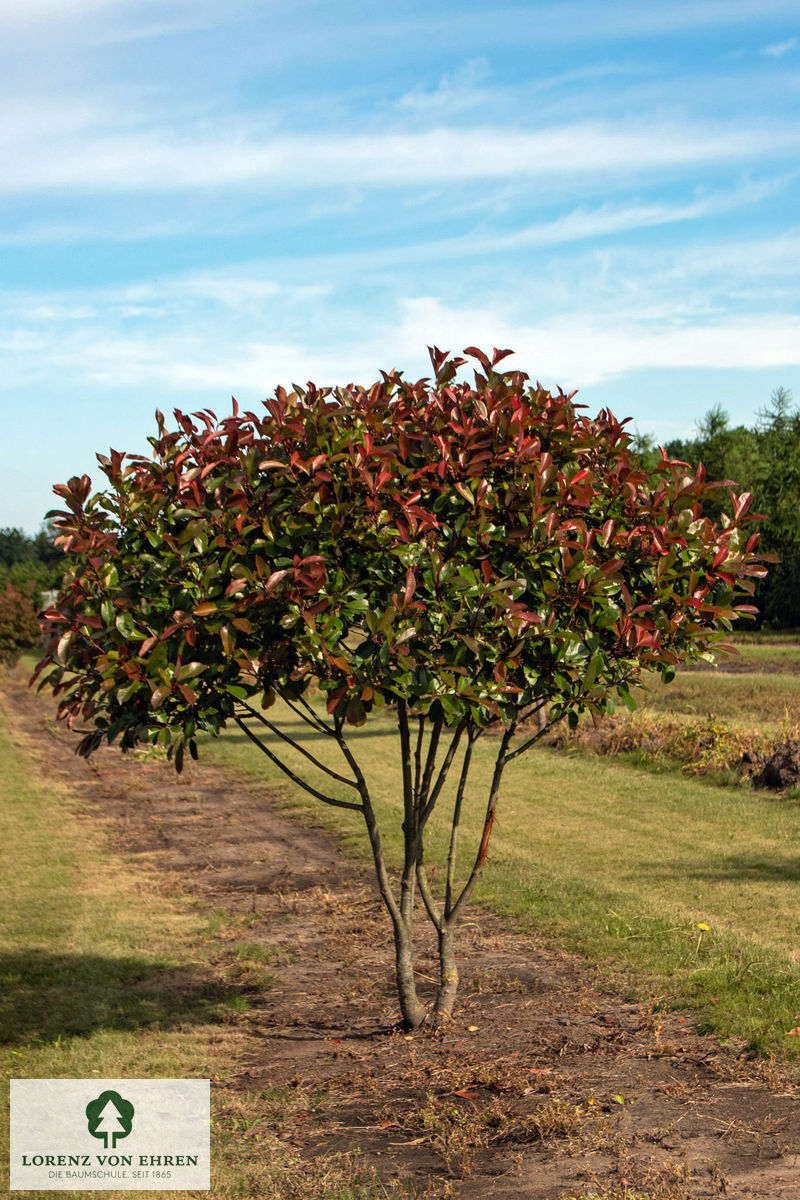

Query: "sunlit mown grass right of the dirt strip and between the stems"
left=204, top=673, right=800, bottom=1058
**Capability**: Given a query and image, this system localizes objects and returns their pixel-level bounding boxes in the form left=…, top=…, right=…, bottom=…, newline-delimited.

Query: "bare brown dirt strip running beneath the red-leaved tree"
left=4, top=684, right=800, bottom=1200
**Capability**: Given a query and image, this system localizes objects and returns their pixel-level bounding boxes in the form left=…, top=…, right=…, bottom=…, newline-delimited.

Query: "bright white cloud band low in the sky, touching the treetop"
left=6, top=279, right=800, bottom=403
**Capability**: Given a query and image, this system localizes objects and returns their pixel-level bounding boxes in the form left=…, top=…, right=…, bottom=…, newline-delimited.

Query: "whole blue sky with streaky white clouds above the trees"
left=0, top=0, right=800, bottom=532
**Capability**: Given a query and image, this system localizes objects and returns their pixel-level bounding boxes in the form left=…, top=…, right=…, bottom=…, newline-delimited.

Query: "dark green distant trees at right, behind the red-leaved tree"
left=638, top=388, right=800, bottom=629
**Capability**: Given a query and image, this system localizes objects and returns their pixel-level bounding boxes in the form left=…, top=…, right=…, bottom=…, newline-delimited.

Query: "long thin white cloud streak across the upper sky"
left=0, top=121, right=800, bottom=193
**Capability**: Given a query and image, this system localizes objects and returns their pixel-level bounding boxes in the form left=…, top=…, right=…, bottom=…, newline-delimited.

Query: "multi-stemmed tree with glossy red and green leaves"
left=38, top=347, right=763, bottom=1028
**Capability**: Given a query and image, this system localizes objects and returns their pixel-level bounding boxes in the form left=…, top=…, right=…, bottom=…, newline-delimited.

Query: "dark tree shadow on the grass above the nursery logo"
left=0, top=950, right=239, bottom=1044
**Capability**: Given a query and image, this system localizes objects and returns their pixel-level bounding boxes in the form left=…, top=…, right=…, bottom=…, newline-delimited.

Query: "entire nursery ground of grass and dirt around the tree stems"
left=0, top=641, right=800, bottom=1200
